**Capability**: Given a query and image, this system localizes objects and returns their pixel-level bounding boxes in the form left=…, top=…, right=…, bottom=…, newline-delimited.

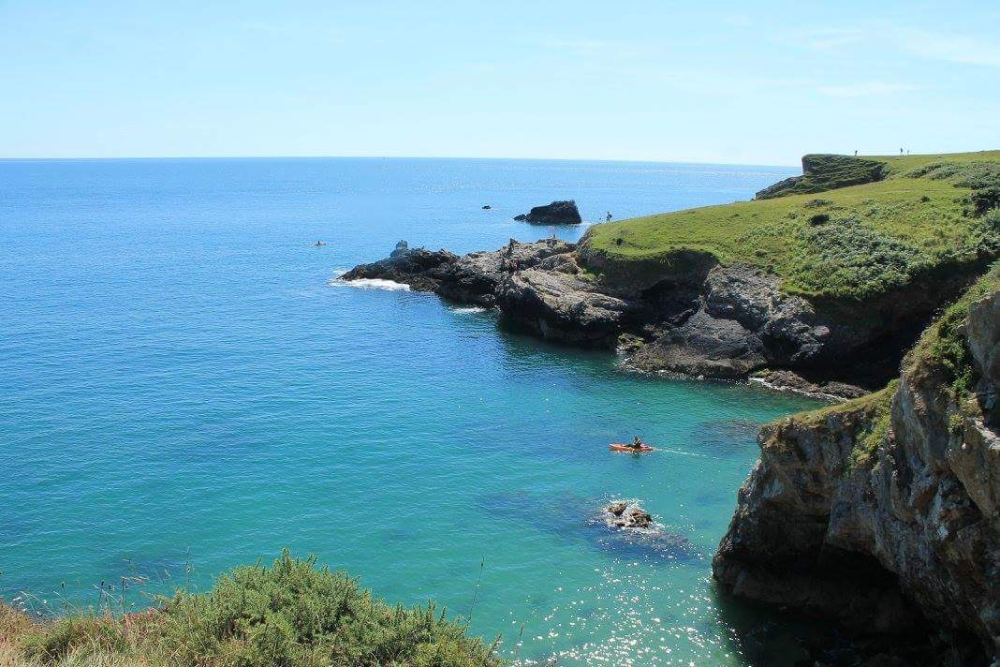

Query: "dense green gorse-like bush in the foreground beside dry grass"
left=166, top=551, right=500, bottom=667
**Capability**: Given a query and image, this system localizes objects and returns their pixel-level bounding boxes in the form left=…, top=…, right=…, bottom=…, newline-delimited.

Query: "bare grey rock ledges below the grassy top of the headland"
left=341, top=238, right=965, bottom=388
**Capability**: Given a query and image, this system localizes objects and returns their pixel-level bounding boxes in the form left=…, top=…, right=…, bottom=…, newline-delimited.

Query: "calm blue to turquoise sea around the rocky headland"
left=0, top=159, right=812, bottom=664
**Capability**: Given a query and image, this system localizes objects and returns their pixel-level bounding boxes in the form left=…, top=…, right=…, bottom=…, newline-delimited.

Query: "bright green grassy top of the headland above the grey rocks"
left=583, top=151, right=1000, bottom=299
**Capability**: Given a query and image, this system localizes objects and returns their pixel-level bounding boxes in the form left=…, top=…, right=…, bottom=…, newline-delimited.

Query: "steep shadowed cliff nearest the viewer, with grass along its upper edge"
left=713, top=270, right=1000, bottom=664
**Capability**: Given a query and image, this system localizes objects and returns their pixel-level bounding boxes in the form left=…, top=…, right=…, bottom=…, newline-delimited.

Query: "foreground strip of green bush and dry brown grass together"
left=6, top=552, right=502, bottom=667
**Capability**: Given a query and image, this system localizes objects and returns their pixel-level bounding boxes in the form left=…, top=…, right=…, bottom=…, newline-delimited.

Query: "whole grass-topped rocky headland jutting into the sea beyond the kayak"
left=341, top=154, right=1000, bottom=398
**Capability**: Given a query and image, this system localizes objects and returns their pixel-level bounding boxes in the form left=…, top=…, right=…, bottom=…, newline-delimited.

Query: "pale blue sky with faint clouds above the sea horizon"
left=0, top=0, right=1000, bottom=164
